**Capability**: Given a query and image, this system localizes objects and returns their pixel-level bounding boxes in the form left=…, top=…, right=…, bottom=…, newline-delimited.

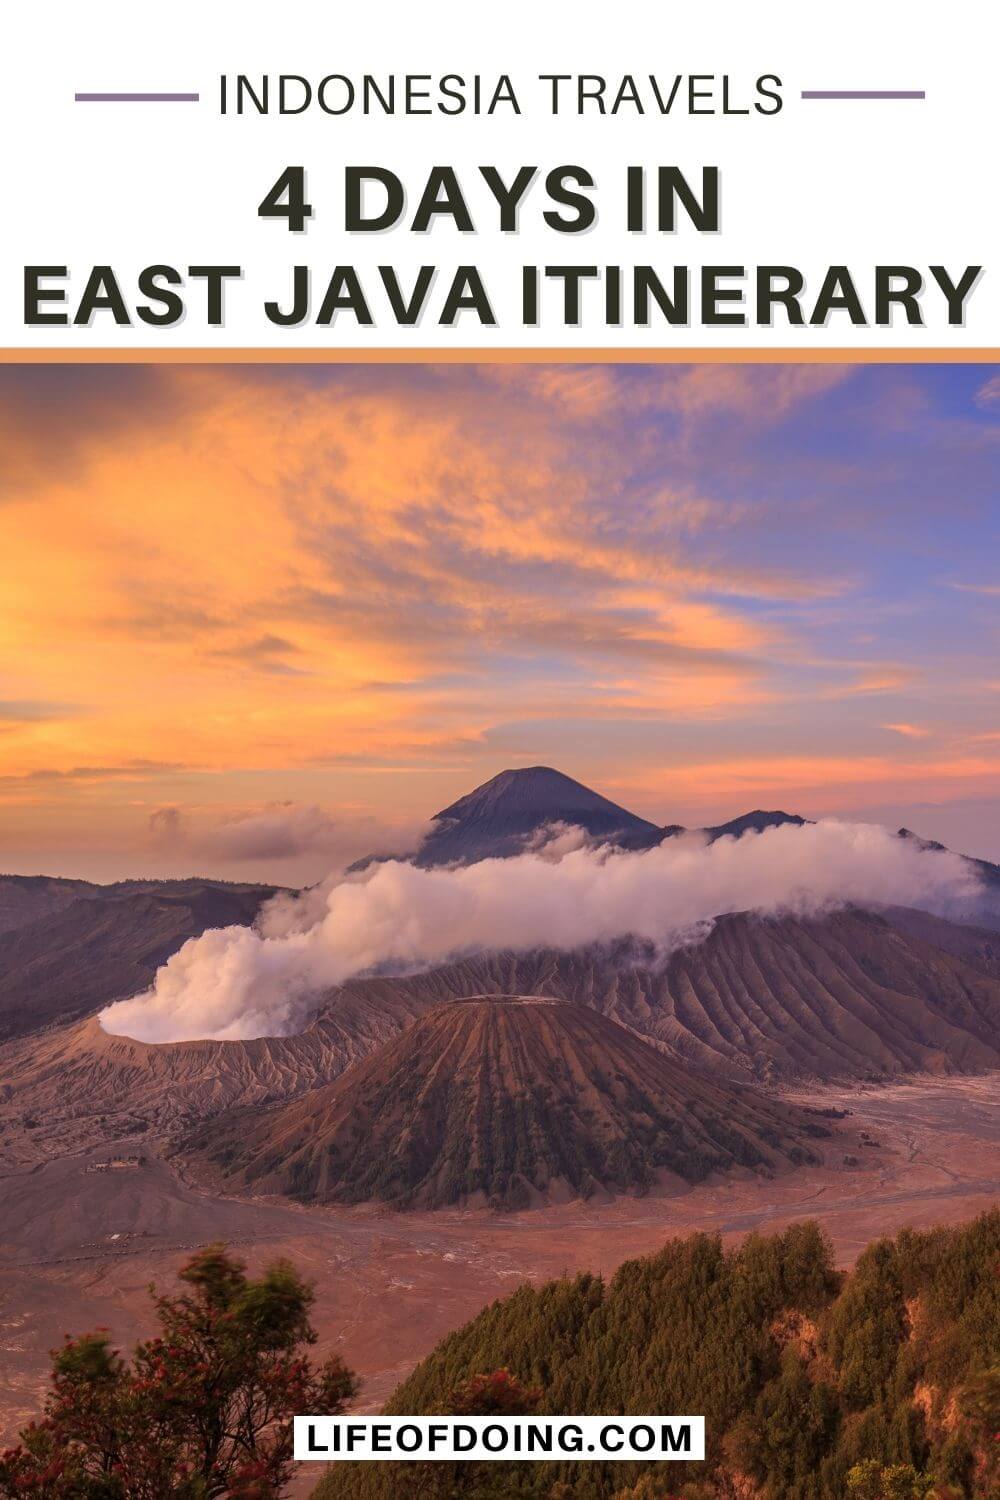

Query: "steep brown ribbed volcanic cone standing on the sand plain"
left=189, top=996, right=829, bottom=1208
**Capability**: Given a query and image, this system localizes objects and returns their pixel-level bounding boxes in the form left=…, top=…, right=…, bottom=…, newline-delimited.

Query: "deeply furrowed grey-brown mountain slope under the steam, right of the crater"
left=353, top=909, right=1000, bottom=1080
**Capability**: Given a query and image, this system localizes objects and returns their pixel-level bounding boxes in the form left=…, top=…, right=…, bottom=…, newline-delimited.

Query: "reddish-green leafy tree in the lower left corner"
left=0, top=1245, right=358, bottom=1500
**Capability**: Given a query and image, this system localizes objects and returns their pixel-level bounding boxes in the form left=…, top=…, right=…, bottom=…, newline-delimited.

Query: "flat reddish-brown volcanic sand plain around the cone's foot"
left=0, top=1073, right=1000, bottom=1470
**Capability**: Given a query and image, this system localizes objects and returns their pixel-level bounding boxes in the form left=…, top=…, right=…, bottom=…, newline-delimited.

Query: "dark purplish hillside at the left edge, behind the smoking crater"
left=0, top=876, right=274, bottom=1041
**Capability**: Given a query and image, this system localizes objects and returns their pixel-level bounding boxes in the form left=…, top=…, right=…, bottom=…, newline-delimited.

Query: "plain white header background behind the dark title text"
left=0, top=0, right=1000, bottom=351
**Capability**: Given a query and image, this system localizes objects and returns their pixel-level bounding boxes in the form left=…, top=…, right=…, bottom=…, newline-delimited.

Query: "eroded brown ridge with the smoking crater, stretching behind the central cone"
left=7, top=909, right=1000, bottom=1170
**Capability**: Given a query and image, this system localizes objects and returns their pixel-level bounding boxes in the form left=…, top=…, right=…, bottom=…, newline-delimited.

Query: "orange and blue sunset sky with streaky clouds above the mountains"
left=0, top=365, right=1000, bottom=882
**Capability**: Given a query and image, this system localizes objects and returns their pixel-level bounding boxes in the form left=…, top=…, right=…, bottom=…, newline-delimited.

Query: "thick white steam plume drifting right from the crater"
left=100, top=822, right=981, bottom=1041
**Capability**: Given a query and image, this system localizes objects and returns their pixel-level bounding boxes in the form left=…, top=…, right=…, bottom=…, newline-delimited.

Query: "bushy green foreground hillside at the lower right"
left=313, top=1211, right=1000, bottom=1500
